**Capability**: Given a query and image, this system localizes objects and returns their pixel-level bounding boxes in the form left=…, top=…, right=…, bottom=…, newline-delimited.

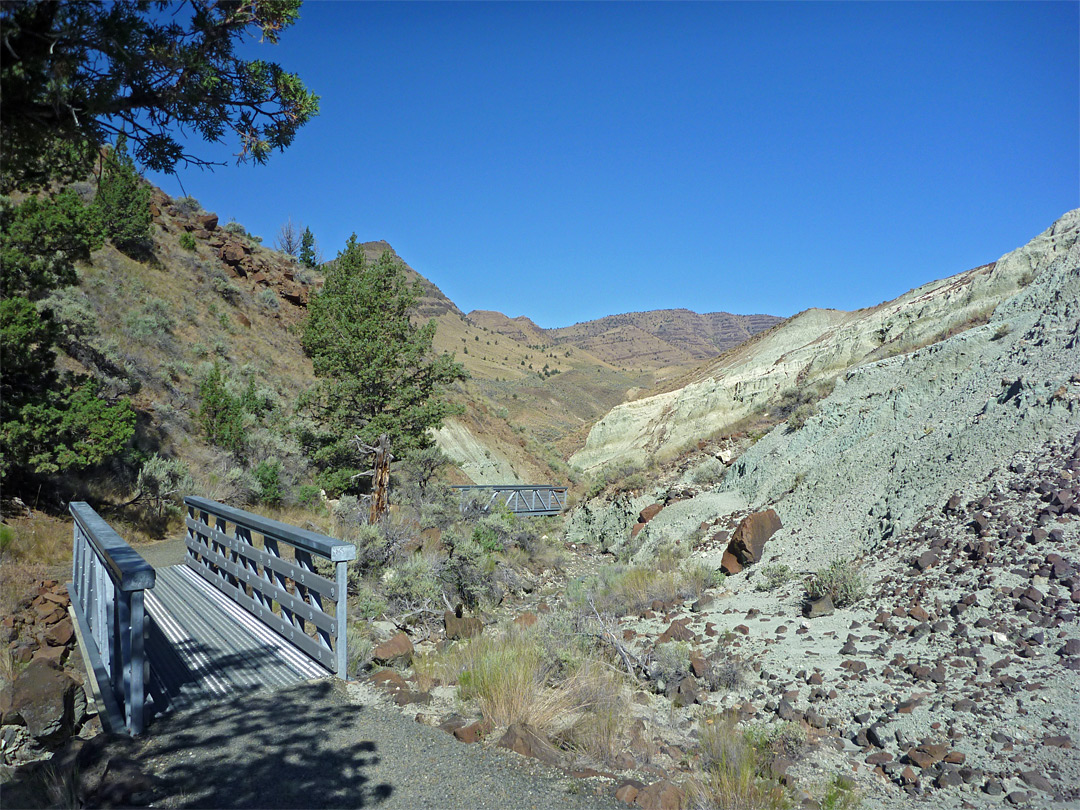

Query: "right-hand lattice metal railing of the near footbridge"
left=184, top=497, right=356, bottom=678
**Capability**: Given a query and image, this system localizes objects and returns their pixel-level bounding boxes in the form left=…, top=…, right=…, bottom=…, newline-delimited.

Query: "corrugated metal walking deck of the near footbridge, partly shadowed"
left=146, top=565, right=333, bottom=714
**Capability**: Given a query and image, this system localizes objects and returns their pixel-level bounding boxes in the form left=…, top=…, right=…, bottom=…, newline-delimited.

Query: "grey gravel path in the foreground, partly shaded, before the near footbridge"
left=137, top=681, right=619, bottom=810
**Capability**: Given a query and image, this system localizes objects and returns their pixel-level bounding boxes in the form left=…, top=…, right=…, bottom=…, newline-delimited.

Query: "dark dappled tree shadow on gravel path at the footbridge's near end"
left=139, top=681, right=393, bottom=808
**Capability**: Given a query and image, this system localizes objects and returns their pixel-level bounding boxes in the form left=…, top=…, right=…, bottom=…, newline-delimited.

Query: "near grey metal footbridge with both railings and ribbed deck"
left=68, top=498, right=356, bottom=733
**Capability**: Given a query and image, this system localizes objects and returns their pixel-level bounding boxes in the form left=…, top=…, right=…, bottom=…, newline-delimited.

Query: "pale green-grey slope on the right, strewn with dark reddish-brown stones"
left=567, top=211, right=1080, bottom=808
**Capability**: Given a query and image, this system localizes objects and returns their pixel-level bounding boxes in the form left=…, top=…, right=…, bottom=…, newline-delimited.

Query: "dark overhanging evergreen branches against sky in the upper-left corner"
left=0, top=0, right=319, bottom=188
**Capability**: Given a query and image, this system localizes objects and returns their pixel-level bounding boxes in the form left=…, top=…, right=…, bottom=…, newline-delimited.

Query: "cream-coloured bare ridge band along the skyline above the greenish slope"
left=571, top=215, right=1075, bottom=470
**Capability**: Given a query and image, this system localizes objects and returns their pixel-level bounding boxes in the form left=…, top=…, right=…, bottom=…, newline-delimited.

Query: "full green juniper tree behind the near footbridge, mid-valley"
left=301, top=234, right=465, bottom=491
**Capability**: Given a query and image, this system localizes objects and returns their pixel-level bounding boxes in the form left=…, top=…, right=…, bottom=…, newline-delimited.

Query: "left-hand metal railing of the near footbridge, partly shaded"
left=68, top=501, right=154, bottom=734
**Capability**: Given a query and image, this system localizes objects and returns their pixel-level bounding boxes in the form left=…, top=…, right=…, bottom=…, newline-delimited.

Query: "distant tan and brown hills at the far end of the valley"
left=341, top=242, right=780, bottom=484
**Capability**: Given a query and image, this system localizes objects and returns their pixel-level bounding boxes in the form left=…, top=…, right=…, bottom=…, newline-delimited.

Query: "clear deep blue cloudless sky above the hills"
left=145, top=2, right=1080, bottom=327
